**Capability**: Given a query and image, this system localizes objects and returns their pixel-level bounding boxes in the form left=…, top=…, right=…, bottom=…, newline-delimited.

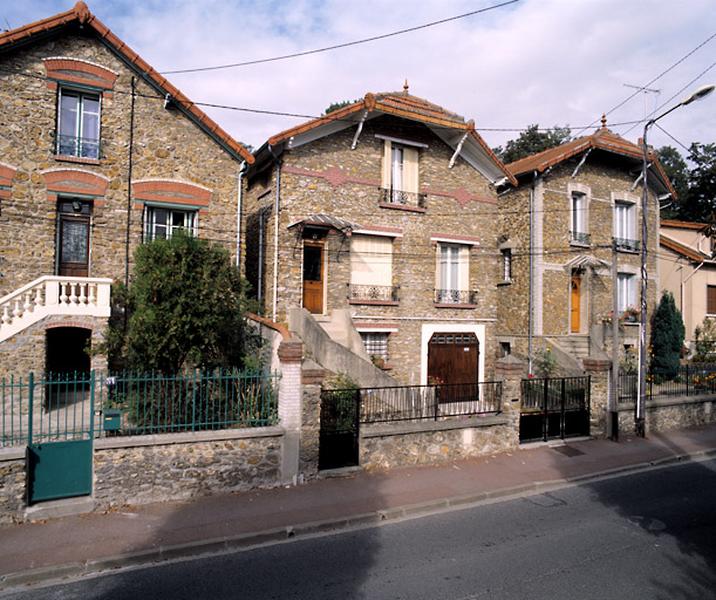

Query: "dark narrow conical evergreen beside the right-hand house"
left=651, top=292, right=686, bottom=379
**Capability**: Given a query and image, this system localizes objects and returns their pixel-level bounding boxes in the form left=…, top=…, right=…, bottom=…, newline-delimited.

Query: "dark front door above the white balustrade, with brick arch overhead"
left=57, top=200, right=91, bottom=277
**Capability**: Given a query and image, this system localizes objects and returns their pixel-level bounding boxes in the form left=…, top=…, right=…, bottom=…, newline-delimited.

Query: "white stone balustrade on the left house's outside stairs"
left=0, top=275, right=112, bottom=342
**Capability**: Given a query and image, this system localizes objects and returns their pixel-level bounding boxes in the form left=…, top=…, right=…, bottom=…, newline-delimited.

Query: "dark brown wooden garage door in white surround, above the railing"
left=428, top=333, right=480, bottom=384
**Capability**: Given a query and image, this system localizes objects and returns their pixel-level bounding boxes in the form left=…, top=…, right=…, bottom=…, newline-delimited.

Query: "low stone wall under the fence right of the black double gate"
left=619, top=396, right=716, bottom=433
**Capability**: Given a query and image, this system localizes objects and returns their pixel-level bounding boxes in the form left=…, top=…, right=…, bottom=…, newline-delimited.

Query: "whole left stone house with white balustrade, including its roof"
left=0, top=2, right=253, bottom=376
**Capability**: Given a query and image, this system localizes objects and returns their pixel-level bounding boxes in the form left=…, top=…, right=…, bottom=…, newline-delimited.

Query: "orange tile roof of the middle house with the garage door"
left=268, top=91, right=517, bottom=184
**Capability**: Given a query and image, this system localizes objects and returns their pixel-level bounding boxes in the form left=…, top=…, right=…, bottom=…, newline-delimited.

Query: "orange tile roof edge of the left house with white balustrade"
left=0, top=2, right=254, bottom=164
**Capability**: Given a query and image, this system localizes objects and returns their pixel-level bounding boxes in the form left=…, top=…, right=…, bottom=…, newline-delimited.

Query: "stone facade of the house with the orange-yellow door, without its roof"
left=497, top=152, right=659, bottom=370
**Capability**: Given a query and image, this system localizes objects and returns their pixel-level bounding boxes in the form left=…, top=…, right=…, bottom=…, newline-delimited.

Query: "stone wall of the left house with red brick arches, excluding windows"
left=0, top=28, right=246, bottom=374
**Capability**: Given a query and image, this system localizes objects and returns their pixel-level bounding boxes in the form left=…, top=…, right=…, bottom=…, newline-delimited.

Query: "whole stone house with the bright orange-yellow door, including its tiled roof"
left=497, top=118, right=675, bottom=373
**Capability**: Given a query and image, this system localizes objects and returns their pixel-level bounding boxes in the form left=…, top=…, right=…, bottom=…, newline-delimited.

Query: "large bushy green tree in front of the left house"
left=107, top=231, right=256, bottom=373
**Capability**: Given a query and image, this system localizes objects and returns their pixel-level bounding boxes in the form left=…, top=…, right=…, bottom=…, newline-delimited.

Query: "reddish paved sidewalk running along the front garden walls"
left=0, top=425, right=716, bottom=589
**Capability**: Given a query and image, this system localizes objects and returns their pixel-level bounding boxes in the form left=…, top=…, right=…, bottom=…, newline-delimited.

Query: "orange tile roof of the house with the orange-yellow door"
left=507, top=119, right=676, bottom=198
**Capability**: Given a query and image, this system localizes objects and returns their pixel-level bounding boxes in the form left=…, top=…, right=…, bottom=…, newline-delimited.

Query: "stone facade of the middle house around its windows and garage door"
left=245, top=115, right=504, bottom=384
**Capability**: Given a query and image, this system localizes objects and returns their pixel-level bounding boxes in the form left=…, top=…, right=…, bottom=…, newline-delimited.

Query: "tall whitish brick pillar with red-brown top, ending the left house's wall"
left=278, top=340, right=303, bottom=484
